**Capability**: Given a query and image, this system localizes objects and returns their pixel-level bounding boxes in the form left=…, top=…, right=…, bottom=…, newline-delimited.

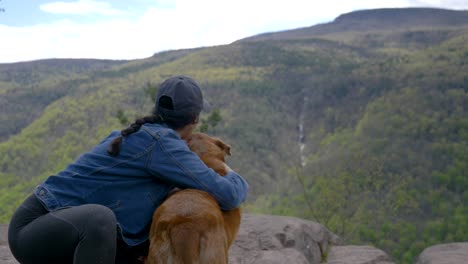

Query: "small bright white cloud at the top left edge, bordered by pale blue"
left=40, top=0, right=125, bottom=16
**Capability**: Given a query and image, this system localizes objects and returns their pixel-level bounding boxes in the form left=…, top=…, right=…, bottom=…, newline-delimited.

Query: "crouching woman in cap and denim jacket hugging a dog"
left=8, top=76, right=248, bottom=264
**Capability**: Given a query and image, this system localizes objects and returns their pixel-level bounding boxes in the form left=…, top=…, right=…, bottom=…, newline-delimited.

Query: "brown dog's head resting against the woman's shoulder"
left=187, top=133, right=231, bottom=175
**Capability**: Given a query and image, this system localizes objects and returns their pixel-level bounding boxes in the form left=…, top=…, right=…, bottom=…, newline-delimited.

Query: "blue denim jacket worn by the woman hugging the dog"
left=34, top=124, right=248, bottom=246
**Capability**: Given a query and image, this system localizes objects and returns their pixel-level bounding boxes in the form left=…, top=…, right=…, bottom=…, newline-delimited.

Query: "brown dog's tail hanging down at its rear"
left=170, top=222, right=200, bottom=264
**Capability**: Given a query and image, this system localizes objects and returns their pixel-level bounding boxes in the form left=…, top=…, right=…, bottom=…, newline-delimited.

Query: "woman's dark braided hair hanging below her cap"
left=107, top=96, right=199, bottom=156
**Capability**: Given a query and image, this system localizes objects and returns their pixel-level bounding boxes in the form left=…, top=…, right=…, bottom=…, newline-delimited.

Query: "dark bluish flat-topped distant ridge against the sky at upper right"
left=238, top=8, right=468, bottom=42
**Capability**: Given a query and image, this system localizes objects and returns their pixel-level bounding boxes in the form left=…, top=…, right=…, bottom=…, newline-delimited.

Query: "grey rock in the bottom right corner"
left=416, top=242, right=468, bottom=264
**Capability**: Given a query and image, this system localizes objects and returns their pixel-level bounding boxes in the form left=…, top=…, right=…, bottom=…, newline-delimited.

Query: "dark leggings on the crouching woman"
left=8, top=195, right=147, bottom=264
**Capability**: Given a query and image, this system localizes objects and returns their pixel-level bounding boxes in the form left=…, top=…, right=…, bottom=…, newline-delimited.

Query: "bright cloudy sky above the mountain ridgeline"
left=0, top=0, right=468, bottom=63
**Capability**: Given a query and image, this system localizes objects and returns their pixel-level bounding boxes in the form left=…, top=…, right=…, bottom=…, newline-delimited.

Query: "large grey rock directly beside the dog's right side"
left=229, top=214, right=341, bottom=264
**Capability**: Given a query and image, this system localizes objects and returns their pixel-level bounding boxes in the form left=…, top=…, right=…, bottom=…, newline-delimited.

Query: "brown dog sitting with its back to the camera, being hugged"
left=146, top=133, right=241, bottom=264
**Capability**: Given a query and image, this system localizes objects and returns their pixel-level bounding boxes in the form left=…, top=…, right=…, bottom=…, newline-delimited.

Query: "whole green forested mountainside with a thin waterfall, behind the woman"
left=0, top=9, right=468, bottom=263
